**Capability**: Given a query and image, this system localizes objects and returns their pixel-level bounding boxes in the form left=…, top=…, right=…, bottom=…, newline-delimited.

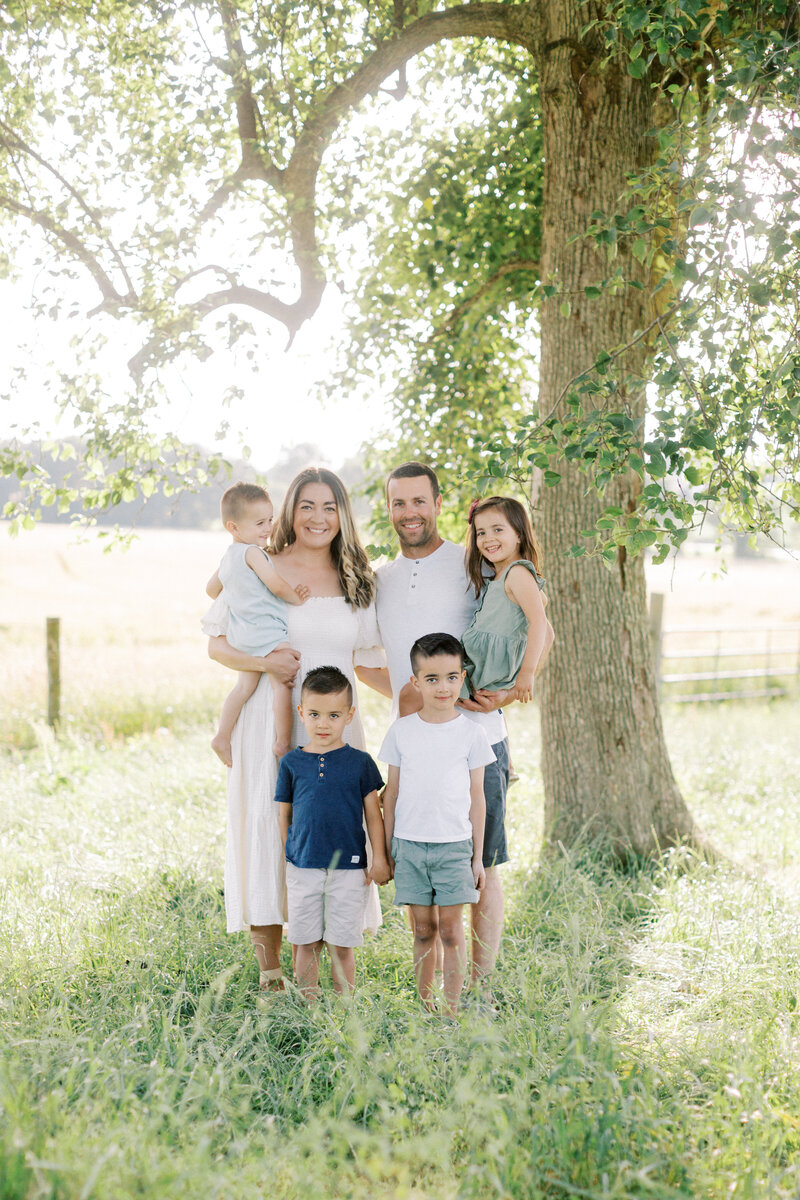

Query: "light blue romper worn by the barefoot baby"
left=218, top=541, right=289, bottom=654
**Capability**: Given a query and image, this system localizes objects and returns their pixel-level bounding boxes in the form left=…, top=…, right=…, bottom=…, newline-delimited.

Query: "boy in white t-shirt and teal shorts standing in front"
left=379, top=634, right=494, bottom=1015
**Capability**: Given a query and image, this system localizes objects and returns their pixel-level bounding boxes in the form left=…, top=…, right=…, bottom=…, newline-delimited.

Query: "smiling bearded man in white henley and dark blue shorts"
left=377, top=462, right=509, bottom=983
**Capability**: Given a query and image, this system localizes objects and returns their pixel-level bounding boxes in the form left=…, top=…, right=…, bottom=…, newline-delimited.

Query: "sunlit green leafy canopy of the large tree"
left=0, top=0, right=800, bottom=554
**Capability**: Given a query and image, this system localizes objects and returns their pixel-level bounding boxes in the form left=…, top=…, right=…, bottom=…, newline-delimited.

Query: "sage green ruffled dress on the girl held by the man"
left=461, top=558, right=545, bottom=700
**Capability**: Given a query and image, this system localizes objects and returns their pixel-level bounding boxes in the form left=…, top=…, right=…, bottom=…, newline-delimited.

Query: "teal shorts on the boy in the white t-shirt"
left=392, top=838, right=479, bottom=907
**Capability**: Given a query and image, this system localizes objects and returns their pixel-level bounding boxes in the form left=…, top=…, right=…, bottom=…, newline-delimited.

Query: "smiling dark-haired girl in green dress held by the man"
left=462, top=496, right=554, bottom=704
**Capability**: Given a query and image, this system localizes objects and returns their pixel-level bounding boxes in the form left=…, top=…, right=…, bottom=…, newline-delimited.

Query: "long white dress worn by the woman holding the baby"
left=203, top=592, right=386, bottom=934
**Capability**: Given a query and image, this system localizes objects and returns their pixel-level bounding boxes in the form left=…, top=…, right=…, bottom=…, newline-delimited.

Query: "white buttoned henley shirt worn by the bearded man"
left=375, top=541, right=506, bottom=744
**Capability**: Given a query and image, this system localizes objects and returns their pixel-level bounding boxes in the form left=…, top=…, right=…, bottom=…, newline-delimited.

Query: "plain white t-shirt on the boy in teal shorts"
left=378, top=713, right=494, bottom=841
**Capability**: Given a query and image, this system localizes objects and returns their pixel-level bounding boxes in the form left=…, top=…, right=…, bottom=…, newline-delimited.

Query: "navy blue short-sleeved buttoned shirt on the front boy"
left=275, top=745, right=384, bottom=871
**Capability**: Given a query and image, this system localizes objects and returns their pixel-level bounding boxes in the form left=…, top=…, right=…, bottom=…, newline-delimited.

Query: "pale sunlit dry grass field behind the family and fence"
left=0, top=526, right=800, bottom=743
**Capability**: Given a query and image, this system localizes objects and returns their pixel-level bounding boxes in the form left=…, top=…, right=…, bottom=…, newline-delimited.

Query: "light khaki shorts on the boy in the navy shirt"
left=287, top=863, right=369, bottom=946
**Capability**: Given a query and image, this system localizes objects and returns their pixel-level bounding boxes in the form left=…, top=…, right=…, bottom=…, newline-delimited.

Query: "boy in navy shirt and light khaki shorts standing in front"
left=275, top=667, right=391, bottom=1000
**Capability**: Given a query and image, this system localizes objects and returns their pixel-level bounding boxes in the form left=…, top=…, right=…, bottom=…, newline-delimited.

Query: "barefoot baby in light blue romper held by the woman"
left=205, top=484, right=309, bottom=767
